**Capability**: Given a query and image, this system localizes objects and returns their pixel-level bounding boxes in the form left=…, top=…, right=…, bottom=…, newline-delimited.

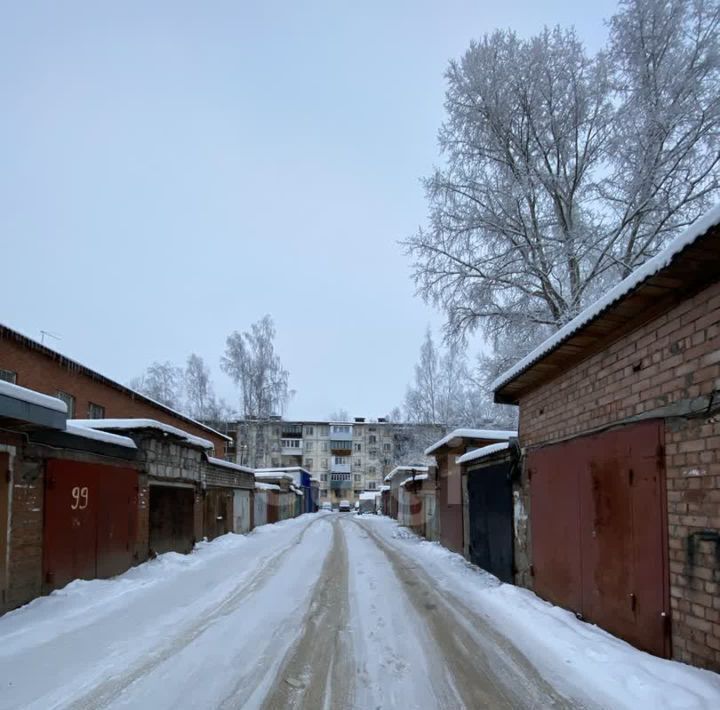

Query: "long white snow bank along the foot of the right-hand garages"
left=362, top=517, right=720, bottom=710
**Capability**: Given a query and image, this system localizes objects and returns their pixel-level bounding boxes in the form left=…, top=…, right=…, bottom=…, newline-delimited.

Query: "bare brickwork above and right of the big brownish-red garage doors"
left=520, top=283, right=720, bottom=670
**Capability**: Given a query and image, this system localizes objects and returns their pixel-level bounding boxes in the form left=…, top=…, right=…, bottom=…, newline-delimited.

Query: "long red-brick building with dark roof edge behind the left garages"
left=0, top=325, right=230, bottom=457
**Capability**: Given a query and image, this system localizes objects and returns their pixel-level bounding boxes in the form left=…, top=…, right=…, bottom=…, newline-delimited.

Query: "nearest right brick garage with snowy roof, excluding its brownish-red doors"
left=495, top=208, right=720, bottom=670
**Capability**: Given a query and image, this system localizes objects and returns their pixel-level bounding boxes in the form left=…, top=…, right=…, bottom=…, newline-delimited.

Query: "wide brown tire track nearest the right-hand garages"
left=352, top=519, right=577, bottom=709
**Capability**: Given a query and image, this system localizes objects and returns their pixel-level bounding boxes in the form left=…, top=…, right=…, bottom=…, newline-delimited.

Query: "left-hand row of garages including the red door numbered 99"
left=0, top=382, right=319, bottom=612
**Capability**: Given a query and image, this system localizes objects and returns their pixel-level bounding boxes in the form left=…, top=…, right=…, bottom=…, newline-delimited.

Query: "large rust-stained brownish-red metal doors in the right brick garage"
left=528, top=421, right=670, bottom=656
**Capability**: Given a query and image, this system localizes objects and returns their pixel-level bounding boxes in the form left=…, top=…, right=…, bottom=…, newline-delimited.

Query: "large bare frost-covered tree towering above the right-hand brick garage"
left=405, top=0, right=720, bottom=358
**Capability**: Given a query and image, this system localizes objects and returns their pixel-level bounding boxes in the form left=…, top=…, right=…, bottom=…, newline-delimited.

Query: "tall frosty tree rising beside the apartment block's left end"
left=220, top=315, right=291, bottom=419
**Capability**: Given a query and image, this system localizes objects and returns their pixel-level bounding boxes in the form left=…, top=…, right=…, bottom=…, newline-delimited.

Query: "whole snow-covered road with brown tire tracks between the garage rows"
left=0, top=513, right=720, bottom=710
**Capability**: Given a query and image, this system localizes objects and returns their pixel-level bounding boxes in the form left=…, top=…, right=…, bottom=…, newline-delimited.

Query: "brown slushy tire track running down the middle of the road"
left=263, top=518, right=354, bottom=710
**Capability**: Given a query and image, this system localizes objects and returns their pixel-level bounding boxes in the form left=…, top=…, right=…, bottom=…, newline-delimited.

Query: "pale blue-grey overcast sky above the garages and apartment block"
left=0, top=0, right=615, bottom=418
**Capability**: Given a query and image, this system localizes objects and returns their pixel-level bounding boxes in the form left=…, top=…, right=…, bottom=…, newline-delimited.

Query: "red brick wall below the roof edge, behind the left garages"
left=0, top=337, right=225, bottom=457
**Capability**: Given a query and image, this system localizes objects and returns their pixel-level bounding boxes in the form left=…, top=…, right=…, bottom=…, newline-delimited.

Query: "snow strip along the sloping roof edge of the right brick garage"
left=491, top=204, right=720, bottom=392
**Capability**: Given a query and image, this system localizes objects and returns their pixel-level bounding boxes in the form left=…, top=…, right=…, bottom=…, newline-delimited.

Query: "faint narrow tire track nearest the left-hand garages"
left=68, top=516, right=325, bottom=710
